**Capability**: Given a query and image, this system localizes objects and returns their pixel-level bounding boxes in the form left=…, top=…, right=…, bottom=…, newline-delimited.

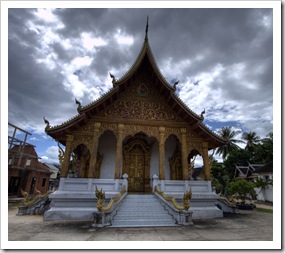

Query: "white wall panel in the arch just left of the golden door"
left=98, top=131, right=116, bottom=179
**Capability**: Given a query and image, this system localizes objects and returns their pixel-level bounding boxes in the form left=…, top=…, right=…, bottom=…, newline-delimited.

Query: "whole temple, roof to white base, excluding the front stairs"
left=45, top=19, right=226, bottom=225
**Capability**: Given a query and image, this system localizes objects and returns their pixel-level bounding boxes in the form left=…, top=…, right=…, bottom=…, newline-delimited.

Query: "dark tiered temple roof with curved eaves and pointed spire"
left=46, top=20, right=226, bottom=149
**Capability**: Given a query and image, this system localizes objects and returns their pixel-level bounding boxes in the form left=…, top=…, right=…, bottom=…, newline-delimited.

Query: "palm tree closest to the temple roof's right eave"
left=216, top=127, right=243, bottom=160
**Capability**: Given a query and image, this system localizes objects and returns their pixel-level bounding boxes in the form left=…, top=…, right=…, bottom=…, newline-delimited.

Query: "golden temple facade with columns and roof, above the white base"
left=45, top=20, right=225, bottom=192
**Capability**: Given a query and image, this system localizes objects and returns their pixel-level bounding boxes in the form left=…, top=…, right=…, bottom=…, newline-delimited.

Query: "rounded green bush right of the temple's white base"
left=227, top=178, right=256, bottom=204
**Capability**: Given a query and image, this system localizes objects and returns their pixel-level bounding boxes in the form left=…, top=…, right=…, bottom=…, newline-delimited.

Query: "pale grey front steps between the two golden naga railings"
left=112, top=194, right=176, bottom=227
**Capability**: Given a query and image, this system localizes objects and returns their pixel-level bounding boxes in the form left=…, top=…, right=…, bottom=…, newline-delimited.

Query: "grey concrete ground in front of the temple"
left=8, top=203, right=273, bottom=242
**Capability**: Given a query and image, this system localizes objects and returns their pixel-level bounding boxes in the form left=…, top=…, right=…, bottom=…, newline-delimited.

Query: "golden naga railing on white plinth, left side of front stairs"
left=92, top=185, right=127, bottom=228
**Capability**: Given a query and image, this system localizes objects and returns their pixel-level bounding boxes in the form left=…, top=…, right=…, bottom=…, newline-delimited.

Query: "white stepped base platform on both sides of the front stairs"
left=44, top=178, right=223, bottom=221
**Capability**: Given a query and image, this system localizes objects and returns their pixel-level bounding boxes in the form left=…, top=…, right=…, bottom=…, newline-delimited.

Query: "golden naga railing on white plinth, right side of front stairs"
left=154, top=186, right=193, bottom=226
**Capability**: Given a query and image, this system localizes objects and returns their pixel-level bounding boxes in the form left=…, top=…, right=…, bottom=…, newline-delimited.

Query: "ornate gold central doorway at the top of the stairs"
left=123, top=135, right=151, bottom=192
